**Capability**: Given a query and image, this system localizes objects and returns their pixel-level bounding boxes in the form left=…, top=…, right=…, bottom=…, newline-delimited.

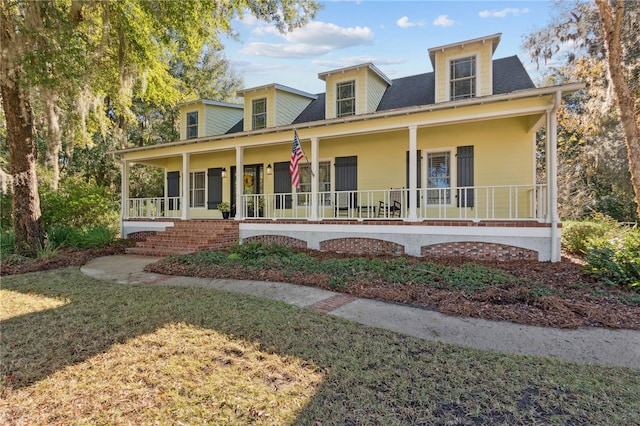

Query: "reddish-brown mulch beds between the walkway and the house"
left=0, top=245, right=640, bottom=330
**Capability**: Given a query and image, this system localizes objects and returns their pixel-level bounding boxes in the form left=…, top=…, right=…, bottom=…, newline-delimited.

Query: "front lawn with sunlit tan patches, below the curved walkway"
left=0, top=268, right=640, bottom=426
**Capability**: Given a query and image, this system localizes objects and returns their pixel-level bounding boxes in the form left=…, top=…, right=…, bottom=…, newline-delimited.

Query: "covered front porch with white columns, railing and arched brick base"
left=116, top=90, right=561, bottom=261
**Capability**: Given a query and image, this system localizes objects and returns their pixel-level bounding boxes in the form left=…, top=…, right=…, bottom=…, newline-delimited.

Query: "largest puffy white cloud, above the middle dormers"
left=240, top=21, right=374, bottom=58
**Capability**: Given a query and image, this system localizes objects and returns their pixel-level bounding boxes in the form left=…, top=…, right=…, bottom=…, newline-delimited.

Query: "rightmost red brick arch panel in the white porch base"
left=420, top=241, right=538, bottom=260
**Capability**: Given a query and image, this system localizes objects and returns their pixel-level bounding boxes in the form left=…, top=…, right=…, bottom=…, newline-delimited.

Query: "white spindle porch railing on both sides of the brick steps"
left=128, top=185, right=547, bottom=221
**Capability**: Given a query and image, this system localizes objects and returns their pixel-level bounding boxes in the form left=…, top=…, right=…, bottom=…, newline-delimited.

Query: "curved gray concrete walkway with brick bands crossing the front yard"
left=81, top=255, right=640, bottom=369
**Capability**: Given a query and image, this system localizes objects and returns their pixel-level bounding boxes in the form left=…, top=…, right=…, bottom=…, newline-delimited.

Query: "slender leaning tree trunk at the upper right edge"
left=595, top=0, right=640, bottom=218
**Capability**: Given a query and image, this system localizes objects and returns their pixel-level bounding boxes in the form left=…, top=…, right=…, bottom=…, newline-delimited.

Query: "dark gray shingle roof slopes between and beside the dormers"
left=227, top=56, right=536, bottom=133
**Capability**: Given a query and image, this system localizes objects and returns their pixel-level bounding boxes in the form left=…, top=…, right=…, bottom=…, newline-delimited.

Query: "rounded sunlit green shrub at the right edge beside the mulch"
left=585, top=227, right=640, bottom=291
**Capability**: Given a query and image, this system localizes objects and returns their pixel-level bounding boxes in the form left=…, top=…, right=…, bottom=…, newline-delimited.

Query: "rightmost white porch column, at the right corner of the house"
left=546, top=91, right=562, bottom=262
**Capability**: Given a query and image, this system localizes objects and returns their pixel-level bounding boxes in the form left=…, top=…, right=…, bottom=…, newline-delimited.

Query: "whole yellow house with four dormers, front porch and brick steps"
left=118, top=34, right=583, bottom=261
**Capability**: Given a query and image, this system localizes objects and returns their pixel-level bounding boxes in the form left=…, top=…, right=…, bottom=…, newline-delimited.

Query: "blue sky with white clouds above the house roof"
left=223, top=0, right=564, bottom=93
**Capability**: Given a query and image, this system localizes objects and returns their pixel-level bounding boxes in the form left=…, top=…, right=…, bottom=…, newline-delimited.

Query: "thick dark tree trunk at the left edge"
left=0, top=1, right=44, bottom=256
